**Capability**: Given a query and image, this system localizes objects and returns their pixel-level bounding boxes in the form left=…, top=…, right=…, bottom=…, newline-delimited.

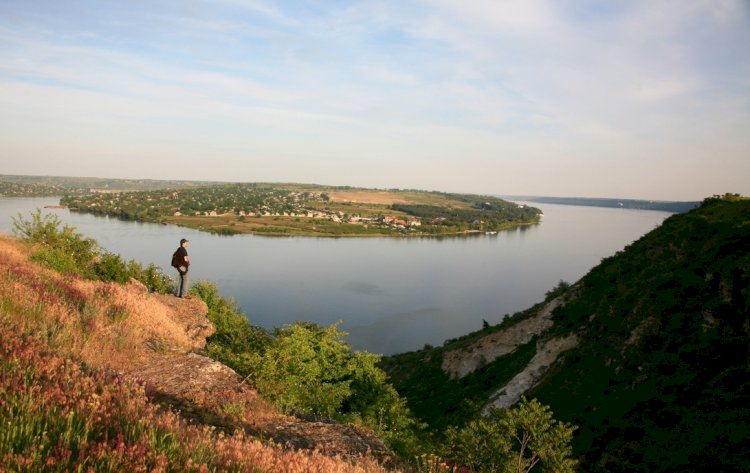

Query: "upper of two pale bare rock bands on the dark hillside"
left=442, top=297, right=562, bottom=378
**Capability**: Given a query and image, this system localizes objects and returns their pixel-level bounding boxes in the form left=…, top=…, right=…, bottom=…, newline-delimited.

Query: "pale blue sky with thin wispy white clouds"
left=0, top=0, right=750, bottom=200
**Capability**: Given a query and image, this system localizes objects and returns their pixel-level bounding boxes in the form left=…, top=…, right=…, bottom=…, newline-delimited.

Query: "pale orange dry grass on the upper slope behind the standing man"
left=0, top=237, right=197, bottom=369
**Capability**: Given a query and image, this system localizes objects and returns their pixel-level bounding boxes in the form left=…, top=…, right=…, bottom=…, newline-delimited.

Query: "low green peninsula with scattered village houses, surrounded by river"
left=60, top=183, right=542, bottom=236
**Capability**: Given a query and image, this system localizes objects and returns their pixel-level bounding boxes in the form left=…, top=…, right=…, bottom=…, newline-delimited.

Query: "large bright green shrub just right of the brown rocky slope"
left=255, top=322, right=421, bottom=454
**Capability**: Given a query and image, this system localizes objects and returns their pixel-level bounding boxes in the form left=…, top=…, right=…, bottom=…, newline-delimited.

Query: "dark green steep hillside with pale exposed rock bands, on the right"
left=384, top=197, right=750, bottom=472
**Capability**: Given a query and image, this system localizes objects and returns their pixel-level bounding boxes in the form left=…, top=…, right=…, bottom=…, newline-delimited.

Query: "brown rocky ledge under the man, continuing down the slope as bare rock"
left=125, top=283, right=393, bottom=463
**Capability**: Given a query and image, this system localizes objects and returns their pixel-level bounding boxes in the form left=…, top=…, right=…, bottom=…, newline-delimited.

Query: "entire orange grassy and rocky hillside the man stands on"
left=0, top=236, right=400, bottom=473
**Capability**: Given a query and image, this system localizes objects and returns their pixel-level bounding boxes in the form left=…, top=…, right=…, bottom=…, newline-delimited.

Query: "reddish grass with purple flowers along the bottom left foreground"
left=0, top=317, right=402, bottom=473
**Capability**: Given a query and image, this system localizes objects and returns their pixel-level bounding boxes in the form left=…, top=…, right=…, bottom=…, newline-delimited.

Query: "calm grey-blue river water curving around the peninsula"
left=0, top=198, right=670, bottom=354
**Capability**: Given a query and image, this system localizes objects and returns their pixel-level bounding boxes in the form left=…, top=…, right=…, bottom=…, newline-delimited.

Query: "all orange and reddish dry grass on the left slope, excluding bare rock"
left=0, top=236, right=406, bottom=473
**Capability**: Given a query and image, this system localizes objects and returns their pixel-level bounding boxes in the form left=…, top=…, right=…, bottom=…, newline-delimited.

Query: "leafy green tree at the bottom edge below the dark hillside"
left=446, top=398, right=577, bottom=473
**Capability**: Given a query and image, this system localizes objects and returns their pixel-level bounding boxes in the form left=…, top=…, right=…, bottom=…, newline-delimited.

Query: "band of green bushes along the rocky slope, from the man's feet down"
left=190, top=281, right=426, bottom=456
